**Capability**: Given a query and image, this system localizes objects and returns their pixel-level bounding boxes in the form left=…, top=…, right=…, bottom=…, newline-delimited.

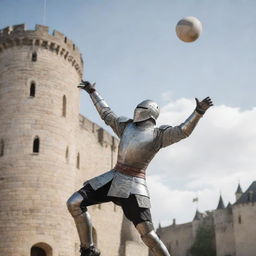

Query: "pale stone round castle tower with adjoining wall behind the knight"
left=0, top=25, right=147, bottom=256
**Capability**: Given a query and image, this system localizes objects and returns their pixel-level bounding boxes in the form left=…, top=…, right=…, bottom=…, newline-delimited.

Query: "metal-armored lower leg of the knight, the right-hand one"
left=136, top=221, right=170, bottom=256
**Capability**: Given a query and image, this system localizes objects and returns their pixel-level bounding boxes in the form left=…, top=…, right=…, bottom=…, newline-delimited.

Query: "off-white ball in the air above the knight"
left=176, top=16, right=202, bottom=42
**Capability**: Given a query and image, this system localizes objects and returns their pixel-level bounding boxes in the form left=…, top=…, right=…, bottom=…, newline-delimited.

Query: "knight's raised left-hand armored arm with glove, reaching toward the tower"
left=78, top=80, right=128, bottom=137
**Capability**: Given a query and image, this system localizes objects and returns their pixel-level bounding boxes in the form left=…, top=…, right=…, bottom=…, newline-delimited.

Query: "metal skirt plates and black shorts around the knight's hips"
left=78, top=169, right=152, bottom=226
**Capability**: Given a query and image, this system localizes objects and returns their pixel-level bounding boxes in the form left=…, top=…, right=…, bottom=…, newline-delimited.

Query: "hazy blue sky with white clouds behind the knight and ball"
left=0, top=0, right=256, bottom=223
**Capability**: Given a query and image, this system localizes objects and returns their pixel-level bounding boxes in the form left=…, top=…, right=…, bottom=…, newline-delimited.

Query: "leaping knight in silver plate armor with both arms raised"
left=67, top=83, right=212, bottom=256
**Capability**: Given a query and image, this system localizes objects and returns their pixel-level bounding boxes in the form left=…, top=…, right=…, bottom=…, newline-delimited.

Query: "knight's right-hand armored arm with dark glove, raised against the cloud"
left=159, top=97, right=213, bottom=148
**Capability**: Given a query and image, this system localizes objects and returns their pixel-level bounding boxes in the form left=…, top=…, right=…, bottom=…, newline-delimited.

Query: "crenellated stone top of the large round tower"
left=0, top=24, right=83, bottom=77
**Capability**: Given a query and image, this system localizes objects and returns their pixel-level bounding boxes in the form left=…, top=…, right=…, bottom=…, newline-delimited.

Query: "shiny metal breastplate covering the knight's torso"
left=117, top=123, right=156, bottom=170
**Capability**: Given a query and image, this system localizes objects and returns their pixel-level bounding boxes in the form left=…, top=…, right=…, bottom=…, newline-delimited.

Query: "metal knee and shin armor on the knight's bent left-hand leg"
left=67, top=192, right=93, bottom=248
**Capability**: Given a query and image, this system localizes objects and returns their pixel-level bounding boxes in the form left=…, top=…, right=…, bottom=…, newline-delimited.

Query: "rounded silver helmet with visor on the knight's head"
left=133, top=100, right=160, bottom=123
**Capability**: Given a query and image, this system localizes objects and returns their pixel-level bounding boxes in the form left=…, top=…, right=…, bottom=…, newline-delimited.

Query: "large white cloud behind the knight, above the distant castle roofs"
left=148, top=98, right=256, bottom=225
